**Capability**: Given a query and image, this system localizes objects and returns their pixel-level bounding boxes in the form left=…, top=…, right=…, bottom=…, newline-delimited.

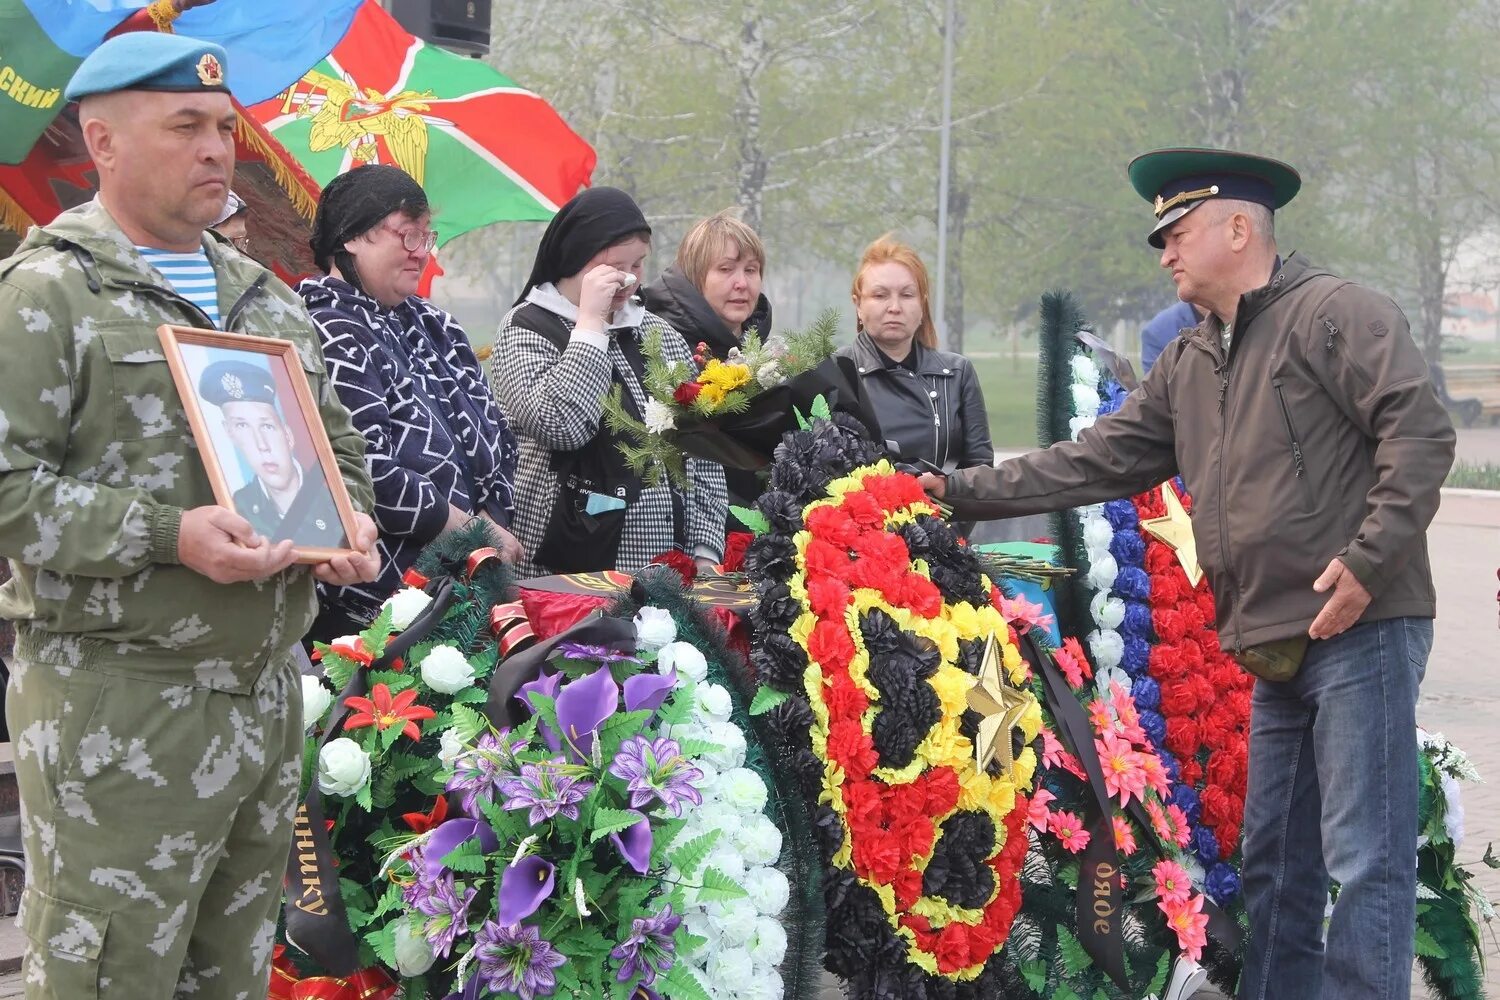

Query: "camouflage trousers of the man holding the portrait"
left=6, top=661, right=302, bottom=1000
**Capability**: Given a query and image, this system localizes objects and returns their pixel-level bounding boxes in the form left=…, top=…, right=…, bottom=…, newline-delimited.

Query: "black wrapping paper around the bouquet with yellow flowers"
left=672, top=357, right=881, bottom=469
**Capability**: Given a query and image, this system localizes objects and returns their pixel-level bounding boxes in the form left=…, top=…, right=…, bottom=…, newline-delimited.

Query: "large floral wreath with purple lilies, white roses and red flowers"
left=276, top=532, right=810, bottom=1000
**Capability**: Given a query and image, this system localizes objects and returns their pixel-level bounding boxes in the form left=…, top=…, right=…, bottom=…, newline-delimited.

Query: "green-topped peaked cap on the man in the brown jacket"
left=1127, top=147, right=1302, bottom=250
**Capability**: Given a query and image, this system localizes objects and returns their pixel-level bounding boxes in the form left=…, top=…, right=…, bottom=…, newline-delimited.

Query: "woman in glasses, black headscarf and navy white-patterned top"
left=297, top=165, right=521, bottom=642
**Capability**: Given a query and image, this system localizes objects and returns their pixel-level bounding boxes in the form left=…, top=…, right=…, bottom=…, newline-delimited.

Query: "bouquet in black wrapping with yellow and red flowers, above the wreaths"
left=605, top=310, right=878, bottom=484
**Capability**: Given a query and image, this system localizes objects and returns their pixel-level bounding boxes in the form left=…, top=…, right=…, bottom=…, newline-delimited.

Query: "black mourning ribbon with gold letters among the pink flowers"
left=1020, top=634, right=1239, bottom=990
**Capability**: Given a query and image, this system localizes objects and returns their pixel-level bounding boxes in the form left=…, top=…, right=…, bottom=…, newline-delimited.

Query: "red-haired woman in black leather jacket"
left=839, top=235, right=995, bottom=472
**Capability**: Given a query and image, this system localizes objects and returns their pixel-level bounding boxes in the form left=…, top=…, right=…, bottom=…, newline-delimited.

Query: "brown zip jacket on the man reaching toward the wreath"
left=947, top=256, right=1455, bottom=651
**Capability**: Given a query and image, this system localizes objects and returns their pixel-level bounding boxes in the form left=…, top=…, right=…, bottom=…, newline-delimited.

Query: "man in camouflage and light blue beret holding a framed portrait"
left=0, top=33, right=377, bottom=1000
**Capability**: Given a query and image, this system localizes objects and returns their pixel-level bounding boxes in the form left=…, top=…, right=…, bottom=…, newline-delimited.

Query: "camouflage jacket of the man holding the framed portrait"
left=0, top=201, right=374, bottom=691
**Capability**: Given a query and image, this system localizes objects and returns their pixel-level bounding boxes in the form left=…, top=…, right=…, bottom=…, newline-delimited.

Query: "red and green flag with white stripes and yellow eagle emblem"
left=249, top=0, right=596, bottom=243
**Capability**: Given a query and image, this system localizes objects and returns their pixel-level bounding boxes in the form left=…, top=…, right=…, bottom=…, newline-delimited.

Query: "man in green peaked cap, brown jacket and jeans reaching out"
left=924, top=148, right=1454, bottom=1000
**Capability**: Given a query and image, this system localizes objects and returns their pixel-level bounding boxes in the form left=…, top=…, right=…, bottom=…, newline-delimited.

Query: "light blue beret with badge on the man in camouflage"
left=63, top=31, right=230, bottom=100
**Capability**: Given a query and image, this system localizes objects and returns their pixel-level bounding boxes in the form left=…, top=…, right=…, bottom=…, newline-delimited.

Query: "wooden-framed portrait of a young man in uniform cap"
left=158, top=325, right=354, bottom=562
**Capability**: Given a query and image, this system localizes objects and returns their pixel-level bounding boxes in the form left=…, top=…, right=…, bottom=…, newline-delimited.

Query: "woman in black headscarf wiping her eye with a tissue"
left=489, top=187, right=728, bottom=574
